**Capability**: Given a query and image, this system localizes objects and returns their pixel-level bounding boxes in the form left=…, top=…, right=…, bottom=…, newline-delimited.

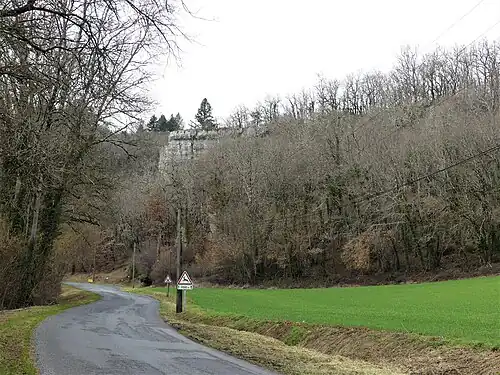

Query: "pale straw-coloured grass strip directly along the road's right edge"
left=124, top=288, right=406, bottom=375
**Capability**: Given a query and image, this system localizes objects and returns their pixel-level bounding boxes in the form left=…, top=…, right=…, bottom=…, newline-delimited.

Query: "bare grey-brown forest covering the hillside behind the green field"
left=65, top=42, right=500, bottom=285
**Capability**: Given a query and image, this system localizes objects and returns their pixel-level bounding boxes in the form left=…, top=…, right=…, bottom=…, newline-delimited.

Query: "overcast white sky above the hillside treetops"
left=152, top=0, right=500, bottom=123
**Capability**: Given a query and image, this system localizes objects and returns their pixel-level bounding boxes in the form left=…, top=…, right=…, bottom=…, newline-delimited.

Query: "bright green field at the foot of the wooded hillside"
left=157, top=276, right=500, bottom=346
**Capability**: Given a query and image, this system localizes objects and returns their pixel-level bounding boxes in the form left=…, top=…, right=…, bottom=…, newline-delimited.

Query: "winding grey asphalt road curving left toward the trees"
left=35, top=284, right=278, bottom=375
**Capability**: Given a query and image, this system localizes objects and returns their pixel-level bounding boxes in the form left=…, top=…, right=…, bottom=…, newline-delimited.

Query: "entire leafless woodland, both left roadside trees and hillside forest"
left=0, top=0, right=500, bottom=308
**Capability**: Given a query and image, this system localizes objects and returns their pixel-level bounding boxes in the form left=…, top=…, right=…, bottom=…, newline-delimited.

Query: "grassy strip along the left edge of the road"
left=0, top=286, right=99, bottom=375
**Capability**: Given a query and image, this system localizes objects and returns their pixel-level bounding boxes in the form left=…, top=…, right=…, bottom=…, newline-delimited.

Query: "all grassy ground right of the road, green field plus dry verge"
left=128, top=277, right=500, bottom=374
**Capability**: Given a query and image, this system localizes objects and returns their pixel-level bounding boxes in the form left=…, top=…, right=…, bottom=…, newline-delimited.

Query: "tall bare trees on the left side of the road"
left=0, top=0, right=186, bottom=308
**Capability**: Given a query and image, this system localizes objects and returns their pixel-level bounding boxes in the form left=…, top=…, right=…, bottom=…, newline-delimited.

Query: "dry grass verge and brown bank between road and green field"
left=127, top=288, right=500, bottom=375
